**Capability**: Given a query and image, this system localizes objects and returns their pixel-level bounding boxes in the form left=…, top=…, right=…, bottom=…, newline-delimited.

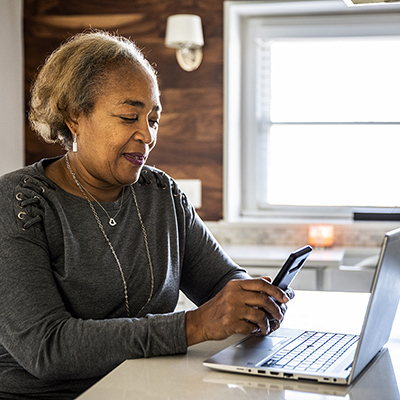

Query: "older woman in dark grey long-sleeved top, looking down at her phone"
left=0, top=32, right=289, bottom=399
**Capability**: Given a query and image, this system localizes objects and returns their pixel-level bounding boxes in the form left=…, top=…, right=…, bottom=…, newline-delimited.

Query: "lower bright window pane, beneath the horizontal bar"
left=264, top=125, right=400, bottom=207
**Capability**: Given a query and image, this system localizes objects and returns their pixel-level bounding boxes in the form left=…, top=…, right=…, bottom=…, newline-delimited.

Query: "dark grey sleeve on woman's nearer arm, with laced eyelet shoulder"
left=0, top=173, right=186, bottom=381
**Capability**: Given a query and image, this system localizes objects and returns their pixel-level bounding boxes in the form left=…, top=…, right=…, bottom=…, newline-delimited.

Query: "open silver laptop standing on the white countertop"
left=203, top=228, right=400, bottom=385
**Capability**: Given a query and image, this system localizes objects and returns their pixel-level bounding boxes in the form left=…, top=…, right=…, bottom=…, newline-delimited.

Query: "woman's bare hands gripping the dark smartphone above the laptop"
left=186, top=277, right=294, bottom=346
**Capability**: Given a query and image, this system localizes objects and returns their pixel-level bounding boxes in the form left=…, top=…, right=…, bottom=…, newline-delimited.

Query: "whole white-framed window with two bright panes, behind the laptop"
left=225, top=1, right=400, bottom=219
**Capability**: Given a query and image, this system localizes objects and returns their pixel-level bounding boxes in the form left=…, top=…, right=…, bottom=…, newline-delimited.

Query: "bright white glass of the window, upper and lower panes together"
left=261, top=37, right=400, bottom=207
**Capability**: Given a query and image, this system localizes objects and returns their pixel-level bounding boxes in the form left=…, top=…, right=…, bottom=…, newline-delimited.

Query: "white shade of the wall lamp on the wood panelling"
left=165, top=14, right=204, bottom=49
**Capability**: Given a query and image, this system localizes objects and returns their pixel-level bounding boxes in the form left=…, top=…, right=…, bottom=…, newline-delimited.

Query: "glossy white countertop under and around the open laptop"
left=78, top=291, right=400, bottom=400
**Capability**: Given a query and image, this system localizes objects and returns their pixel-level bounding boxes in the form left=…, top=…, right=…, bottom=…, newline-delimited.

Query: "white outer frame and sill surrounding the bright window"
left=224, top=0, right=400, bottom=222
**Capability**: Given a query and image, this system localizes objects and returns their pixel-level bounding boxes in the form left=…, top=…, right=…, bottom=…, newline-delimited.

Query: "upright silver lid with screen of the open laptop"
left=349, top=229, right=400, bottom=383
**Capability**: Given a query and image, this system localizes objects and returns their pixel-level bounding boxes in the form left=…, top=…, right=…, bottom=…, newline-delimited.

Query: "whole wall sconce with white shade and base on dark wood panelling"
left=165, top=14, right=204, bottom=71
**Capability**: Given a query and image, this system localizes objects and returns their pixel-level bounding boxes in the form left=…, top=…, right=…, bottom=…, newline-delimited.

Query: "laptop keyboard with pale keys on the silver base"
left=262, top=332, right=359, bottom=372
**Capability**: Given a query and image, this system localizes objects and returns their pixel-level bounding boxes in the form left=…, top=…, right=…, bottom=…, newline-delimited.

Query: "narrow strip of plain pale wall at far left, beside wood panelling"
left=0, top=0, right=25, bottom=175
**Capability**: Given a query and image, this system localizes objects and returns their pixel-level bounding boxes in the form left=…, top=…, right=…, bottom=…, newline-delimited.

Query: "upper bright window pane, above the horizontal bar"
left=270, top=37, right=400, bottom=122
